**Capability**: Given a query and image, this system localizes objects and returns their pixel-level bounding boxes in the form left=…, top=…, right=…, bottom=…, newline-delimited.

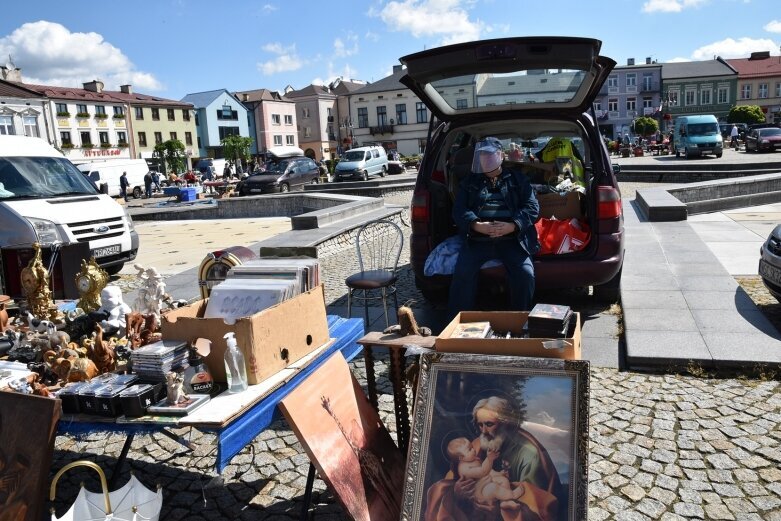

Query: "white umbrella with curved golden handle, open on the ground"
left=49, top=460, right=163, bottom=521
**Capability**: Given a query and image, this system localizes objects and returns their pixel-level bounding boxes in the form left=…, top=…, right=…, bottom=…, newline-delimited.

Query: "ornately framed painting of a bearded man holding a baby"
left=401, top=353, right=589, bottom=521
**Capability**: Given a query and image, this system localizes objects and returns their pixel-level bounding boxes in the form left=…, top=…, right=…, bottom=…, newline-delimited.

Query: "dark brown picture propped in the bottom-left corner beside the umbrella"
left=0, top=391, right=60, bottom=521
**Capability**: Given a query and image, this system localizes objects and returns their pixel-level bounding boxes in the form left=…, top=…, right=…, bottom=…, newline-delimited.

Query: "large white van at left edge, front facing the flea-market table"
left=0, top=136, right=138, bottom=286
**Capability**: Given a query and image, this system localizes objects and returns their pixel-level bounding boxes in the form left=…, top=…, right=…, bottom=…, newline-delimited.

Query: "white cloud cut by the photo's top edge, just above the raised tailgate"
left=369, top=0, right=486, bottom=45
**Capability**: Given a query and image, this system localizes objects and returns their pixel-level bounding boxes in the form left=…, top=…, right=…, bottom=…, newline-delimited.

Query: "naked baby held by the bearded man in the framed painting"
left=447, top=438, right=526, bottom=508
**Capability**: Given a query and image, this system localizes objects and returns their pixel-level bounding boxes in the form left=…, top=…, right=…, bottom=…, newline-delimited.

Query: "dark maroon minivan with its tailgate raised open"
left=400, top=37, right=624, bottom=301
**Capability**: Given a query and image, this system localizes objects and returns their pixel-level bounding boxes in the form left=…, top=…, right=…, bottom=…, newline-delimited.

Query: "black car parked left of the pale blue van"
left=236, top=157, right=320, bottom=195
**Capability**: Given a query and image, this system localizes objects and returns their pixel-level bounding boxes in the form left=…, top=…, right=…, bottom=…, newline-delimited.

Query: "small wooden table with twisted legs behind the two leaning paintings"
left=357, top=331, right=437, bottom=454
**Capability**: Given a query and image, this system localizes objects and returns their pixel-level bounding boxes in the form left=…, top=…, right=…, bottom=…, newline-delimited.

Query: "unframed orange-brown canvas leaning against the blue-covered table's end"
left=280, top=353, right=404, bottom=521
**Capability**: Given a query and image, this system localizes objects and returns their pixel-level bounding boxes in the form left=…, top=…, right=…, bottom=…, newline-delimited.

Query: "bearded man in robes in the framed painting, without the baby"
left=424, top=396, right=567, bottom=521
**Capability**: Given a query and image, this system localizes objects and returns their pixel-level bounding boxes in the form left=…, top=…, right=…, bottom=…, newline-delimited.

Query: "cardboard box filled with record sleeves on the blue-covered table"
left=161, top=285, right=329, bottom=385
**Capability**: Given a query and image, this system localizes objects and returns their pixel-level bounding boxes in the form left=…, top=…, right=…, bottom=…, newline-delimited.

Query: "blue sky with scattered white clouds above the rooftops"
left=0, top=0, right=781, bottom=99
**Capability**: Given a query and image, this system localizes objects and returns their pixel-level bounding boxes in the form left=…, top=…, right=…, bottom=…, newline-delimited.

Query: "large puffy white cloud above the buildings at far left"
left=0, top=20, right=163, bottom=91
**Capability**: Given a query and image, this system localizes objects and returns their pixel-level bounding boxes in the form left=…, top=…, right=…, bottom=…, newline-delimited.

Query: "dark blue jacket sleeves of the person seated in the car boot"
left=453, top=169, right=540, bottom=256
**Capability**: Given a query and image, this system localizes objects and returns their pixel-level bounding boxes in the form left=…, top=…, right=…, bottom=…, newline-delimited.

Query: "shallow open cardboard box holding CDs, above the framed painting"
left=434, top=311, right=581, bottom=360
